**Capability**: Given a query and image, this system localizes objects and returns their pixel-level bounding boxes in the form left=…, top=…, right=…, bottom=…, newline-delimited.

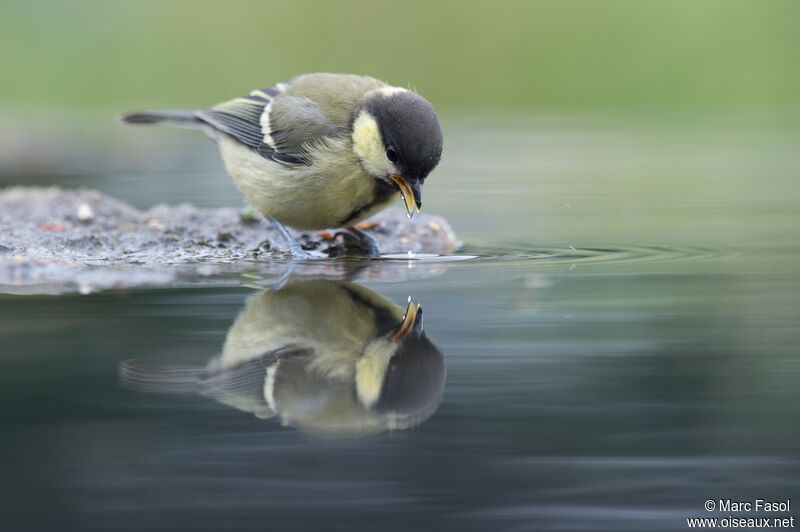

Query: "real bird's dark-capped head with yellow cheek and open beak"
left=353, top=87, right=442, bottom=216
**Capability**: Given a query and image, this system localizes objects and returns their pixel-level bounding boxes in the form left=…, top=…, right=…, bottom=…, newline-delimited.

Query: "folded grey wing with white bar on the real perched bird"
left=195, top=85, right=338, bottom=164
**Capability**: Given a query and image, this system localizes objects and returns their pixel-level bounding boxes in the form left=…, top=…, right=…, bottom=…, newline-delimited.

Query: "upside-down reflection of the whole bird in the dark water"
left=120, top=280, right=445, bottom=435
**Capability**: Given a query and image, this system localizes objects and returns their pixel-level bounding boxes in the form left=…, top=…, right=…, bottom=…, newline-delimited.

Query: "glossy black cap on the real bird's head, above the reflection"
left=364, top=89, right=442, bottom=180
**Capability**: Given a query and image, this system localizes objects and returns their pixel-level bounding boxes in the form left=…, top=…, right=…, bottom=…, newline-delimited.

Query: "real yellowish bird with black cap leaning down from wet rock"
left=121, top=73, right=443, bottom=257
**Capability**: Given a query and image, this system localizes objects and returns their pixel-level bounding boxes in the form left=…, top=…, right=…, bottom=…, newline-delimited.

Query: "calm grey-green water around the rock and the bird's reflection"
left=0, top=120, right=800, bottom=530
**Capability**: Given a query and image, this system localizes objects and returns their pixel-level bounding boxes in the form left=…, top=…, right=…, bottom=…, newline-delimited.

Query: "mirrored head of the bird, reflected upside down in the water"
left=356, top=298, right=446, bottom=428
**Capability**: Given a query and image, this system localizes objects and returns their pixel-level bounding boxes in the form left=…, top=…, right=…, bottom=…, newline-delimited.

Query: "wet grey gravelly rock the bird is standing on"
left=0, top=187, right=458, bottom=292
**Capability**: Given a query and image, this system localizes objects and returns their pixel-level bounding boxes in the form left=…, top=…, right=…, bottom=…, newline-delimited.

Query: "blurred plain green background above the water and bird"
left=0, top=0, right=800, bottom=113
